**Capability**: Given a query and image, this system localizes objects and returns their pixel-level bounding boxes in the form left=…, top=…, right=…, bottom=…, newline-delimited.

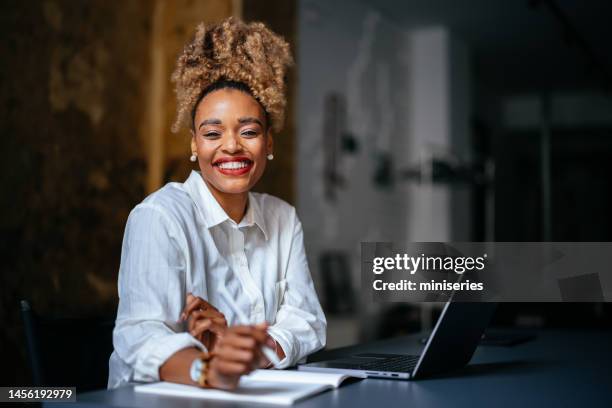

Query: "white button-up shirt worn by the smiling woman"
left=108, top=171, right=327, bottom=388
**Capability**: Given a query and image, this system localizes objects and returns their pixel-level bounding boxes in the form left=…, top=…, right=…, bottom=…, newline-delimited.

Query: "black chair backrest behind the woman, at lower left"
left=21, top=300, right=115, bottom=392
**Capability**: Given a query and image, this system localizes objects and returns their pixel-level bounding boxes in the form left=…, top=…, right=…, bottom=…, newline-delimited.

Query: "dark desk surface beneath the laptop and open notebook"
left=47, top=331, right=612, bottom=408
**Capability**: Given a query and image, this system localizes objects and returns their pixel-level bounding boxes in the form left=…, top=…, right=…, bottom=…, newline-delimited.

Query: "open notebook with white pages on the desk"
left=134, top=370, right=349, bottom=405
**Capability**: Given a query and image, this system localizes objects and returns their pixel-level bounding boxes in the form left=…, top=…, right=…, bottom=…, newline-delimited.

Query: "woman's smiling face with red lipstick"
left=191, top=88, right=272, bottom=196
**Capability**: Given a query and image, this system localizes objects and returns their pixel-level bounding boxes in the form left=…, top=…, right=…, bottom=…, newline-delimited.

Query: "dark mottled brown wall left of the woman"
left=0, top=1, right=153, bottom=384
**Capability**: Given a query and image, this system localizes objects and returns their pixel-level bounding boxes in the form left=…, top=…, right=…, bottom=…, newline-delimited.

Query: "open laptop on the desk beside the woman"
left=298, top=301, right=497, bottom=380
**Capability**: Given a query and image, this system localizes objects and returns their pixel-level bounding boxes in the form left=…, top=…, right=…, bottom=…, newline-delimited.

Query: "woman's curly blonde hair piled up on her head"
left=172, top=17, right=293, bottom=132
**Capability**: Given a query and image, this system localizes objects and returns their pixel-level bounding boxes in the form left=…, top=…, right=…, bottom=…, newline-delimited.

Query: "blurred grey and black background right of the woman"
left=297, top=0, right=612, bottom=346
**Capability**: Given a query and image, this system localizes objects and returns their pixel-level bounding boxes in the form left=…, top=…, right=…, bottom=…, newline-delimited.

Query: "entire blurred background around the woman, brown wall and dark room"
left=0, top=0, right=612, bottom=384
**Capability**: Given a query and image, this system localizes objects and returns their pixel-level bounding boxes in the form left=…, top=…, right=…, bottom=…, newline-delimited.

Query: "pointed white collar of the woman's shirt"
left=183, top=170, right=268, bottom=240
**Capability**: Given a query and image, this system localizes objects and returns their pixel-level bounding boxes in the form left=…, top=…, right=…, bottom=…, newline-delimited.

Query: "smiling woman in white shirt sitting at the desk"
left=109, top=18, right=326, bottom=389
